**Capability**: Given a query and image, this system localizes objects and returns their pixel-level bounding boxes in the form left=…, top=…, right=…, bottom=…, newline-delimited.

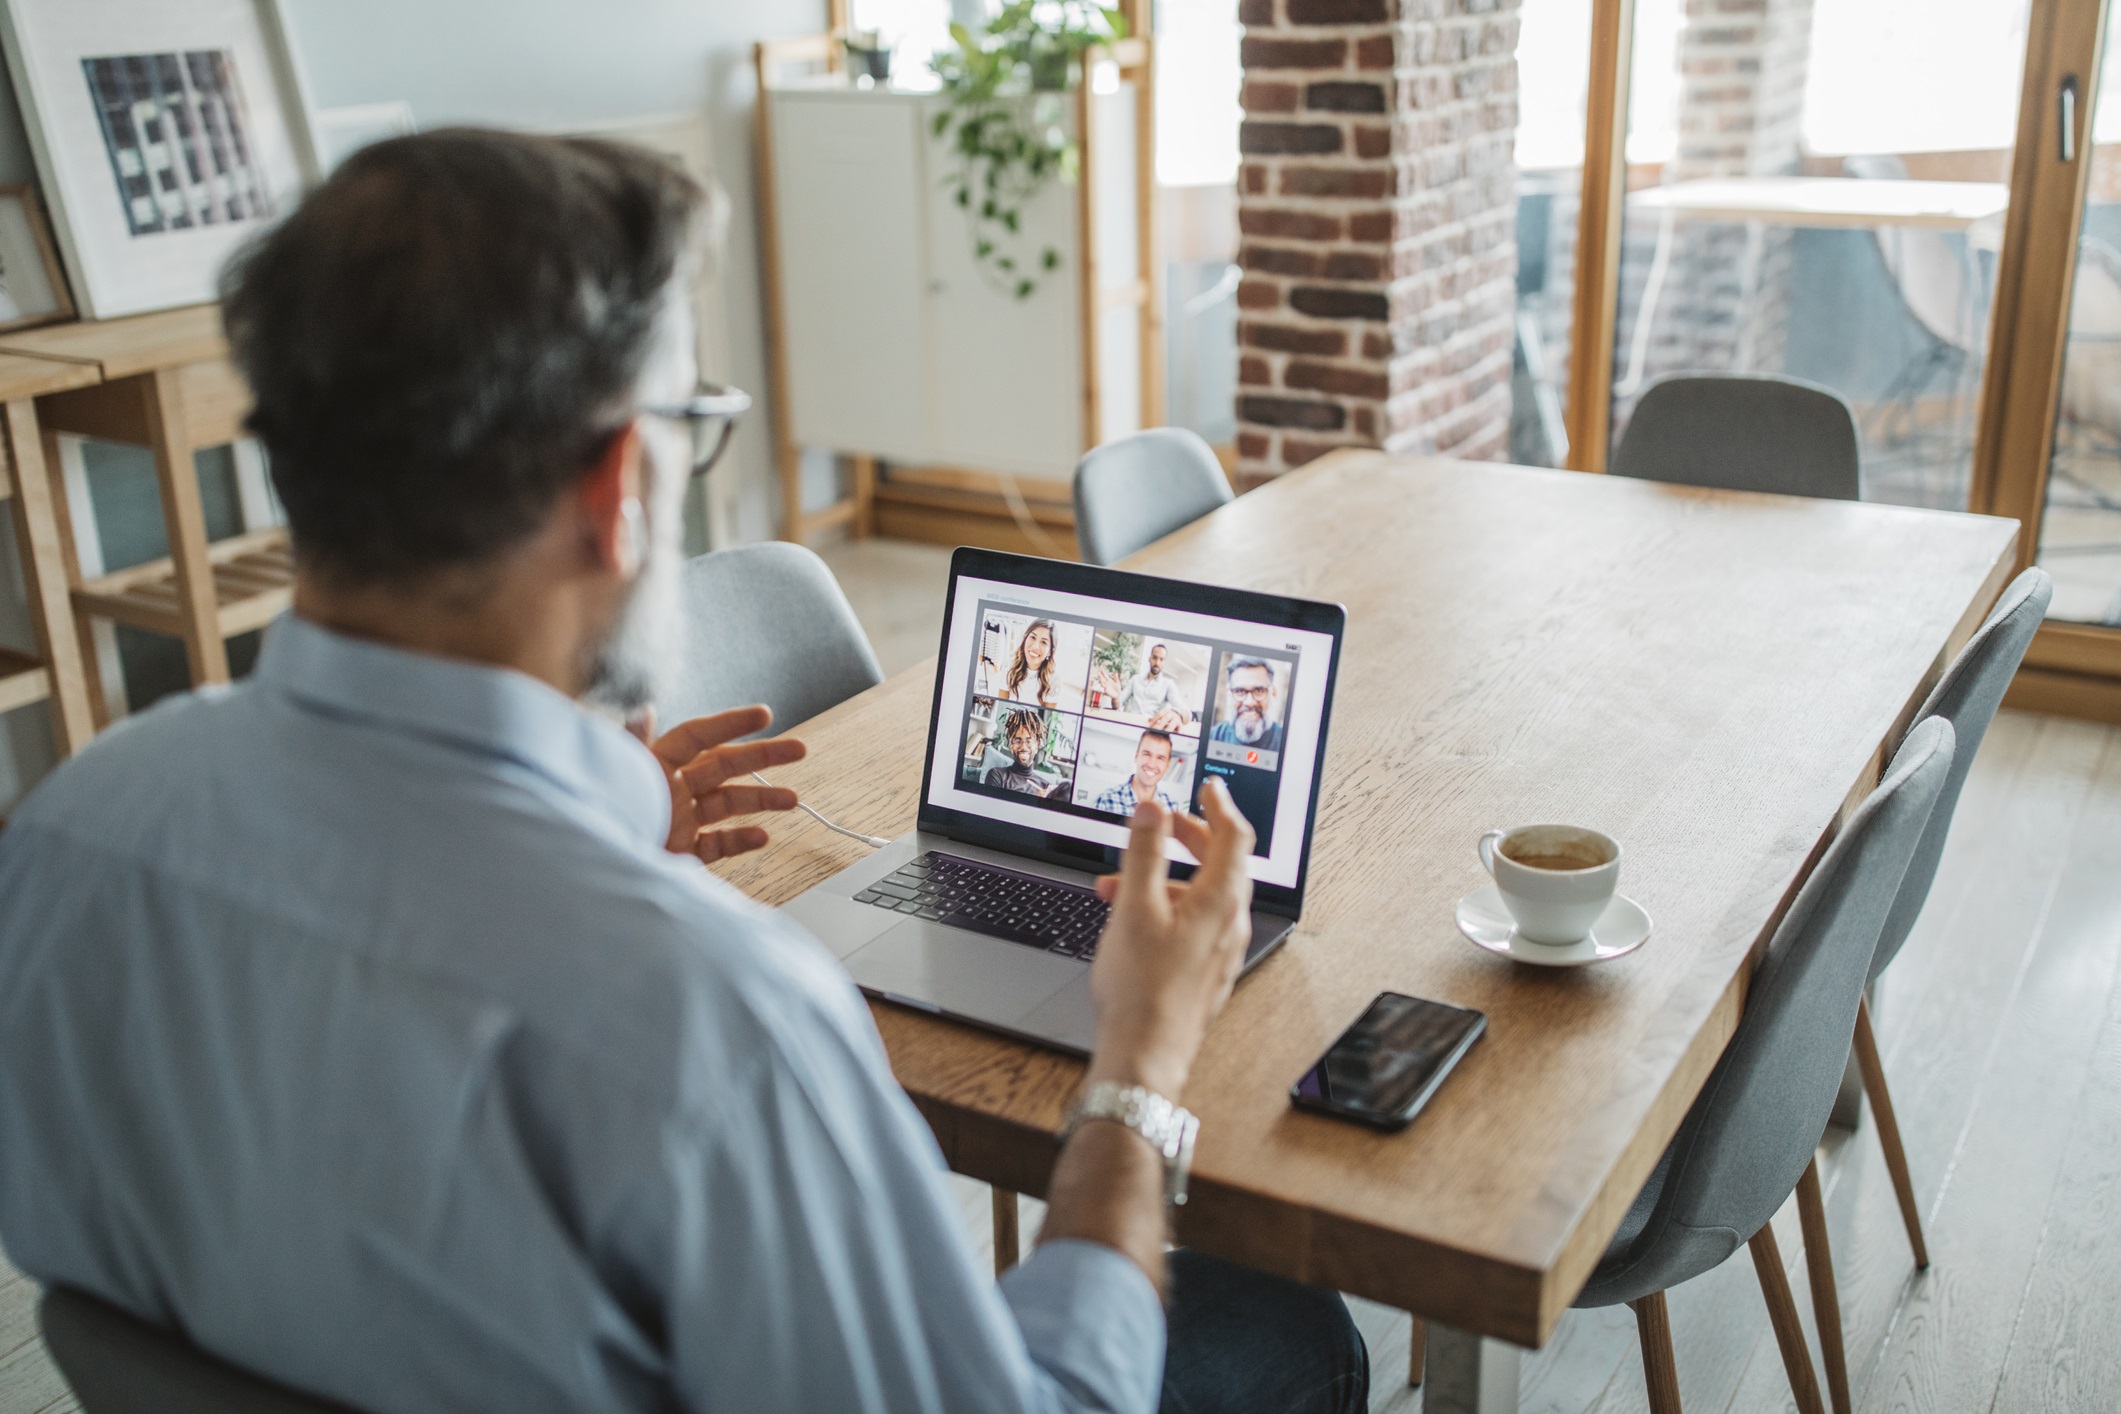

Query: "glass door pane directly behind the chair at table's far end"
left=1608, top=0, right=2032, bottom=509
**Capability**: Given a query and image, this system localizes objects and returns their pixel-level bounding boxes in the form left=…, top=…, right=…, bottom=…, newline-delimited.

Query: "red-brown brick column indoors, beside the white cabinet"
left=1237, top=0, right=1519, bottom=477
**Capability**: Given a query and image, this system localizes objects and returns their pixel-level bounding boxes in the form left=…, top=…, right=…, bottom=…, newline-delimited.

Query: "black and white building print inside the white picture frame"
left=81, top=49, right=274, bottom=235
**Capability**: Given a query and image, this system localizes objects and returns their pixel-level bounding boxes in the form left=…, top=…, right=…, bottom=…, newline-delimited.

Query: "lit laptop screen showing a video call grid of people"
left=929, top=577, right=1332, bottom=886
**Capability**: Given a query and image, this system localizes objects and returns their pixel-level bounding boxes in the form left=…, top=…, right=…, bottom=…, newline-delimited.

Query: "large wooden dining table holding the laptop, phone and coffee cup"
left=721, top=452, right=2017, bottom=1414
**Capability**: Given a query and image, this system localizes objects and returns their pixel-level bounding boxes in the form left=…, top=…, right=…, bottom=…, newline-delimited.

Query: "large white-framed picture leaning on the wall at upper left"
left=0, top=0, right=318, bottom=318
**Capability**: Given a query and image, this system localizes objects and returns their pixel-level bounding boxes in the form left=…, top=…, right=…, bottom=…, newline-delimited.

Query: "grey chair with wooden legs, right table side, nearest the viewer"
left=1576, top=717, right=1953, bottom=1414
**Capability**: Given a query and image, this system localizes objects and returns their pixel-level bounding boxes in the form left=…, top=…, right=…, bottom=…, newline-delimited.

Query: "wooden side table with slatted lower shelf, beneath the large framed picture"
left=0, top=305, right=279, bottom=702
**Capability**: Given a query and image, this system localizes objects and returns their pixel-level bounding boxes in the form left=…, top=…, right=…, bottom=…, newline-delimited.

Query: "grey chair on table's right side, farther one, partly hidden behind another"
left=1856, top=568, right=2055, bottom=1270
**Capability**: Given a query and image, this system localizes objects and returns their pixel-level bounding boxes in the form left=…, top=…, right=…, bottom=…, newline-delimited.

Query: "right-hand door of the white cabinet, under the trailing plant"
left=921, top=100, right=1084, bottom=477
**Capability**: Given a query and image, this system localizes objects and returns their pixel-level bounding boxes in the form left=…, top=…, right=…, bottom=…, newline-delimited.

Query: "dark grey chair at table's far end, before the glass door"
left=1610, top=373, right=1862, bottom=500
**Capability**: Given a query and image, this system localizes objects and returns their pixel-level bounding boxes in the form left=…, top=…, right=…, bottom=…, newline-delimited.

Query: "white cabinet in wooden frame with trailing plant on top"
left=761, top=64, right=1160, bottom=519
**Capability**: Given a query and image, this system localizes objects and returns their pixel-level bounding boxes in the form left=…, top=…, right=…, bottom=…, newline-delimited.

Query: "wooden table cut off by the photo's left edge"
left=0, top=354, right=100, bottom=757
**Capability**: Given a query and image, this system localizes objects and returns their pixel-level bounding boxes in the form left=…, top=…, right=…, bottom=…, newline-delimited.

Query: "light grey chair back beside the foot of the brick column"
left=1075, top=426, right=1232, bottom=564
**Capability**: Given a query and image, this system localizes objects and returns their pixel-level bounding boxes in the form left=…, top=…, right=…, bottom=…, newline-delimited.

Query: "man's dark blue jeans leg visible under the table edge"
left=1162, top=1249, right=1370, bottom=1414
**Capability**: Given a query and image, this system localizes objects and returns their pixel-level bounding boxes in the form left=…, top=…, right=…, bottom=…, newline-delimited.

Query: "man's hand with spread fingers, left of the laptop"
left=630, top=706, right=808, bottom=865
